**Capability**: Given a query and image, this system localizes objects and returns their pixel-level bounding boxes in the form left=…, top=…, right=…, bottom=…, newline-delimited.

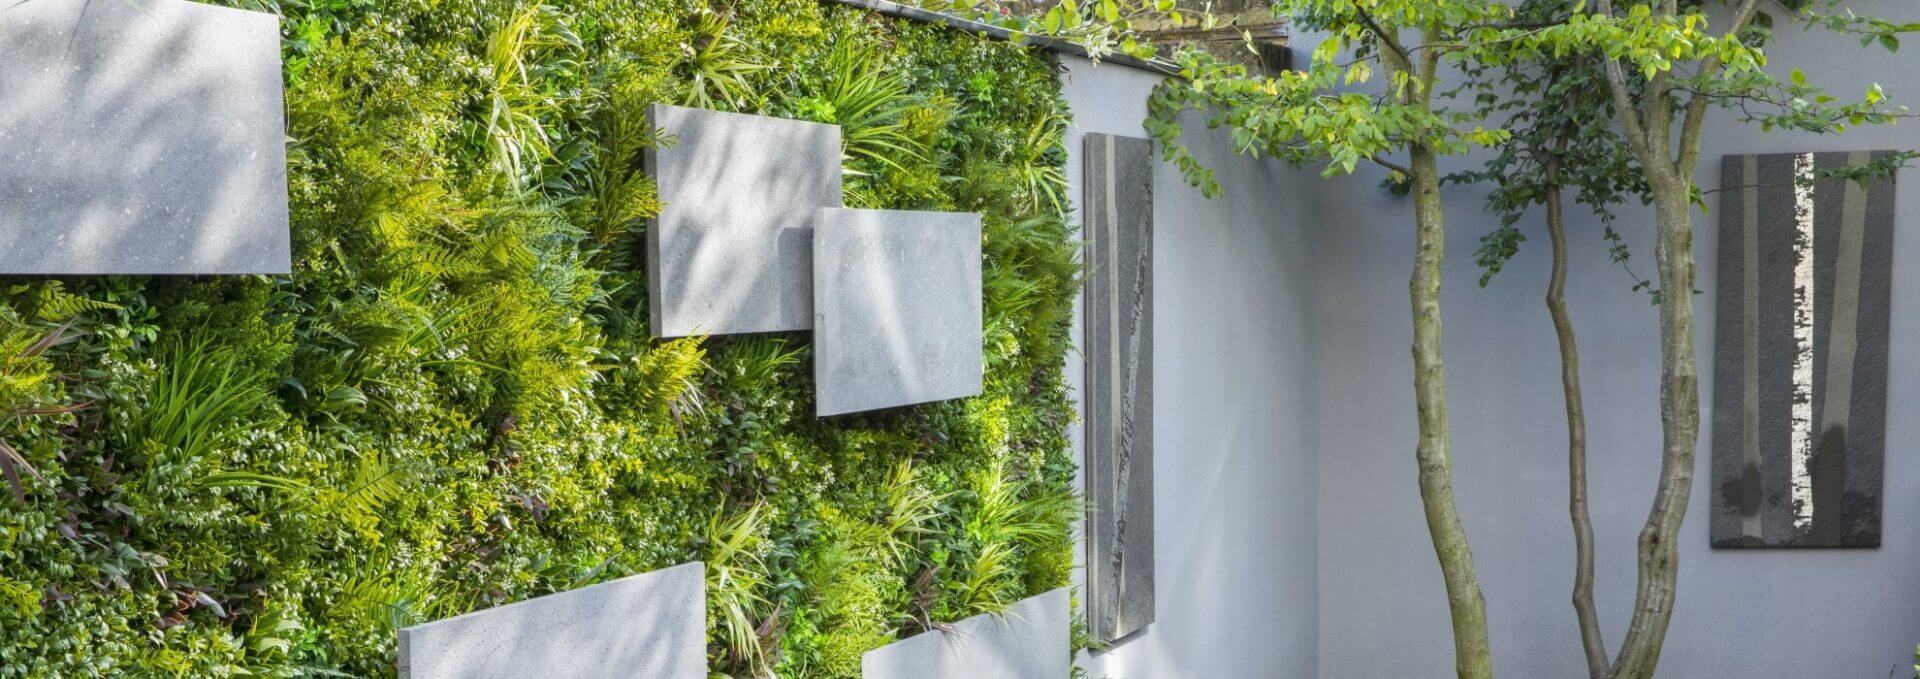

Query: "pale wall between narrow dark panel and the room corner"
left=1062, top=58, right=1319, bottom=679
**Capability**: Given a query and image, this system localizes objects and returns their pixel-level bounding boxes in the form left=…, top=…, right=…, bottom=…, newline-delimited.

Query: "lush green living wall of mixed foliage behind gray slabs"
left=0, top=0, right=1077, bottom=677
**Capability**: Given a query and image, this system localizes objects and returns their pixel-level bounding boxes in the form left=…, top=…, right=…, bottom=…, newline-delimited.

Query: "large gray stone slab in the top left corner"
left=0, top=0, right=290, bottom=274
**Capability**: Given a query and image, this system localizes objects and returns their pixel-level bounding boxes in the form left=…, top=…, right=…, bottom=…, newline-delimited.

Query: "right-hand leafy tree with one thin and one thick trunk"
left=1488, top=0, right=1920, bottom=677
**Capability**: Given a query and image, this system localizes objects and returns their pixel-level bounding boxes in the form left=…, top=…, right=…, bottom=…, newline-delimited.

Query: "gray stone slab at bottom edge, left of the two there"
left=399, top=562, right=707, bottom=679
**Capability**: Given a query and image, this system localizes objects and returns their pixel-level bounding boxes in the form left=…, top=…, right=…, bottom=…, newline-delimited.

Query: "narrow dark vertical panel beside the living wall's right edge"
left=1083, top=134, right=1154, bottom=643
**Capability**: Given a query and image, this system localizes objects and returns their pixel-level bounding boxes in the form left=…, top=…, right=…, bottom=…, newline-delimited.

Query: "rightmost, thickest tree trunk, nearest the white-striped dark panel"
left=1613, top=181, right=1699, bottom=679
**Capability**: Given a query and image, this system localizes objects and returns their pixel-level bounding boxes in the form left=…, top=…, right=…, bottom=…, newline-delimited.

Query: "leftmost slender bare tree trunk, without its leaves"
left=1407, top=146, right=1494, bottom=679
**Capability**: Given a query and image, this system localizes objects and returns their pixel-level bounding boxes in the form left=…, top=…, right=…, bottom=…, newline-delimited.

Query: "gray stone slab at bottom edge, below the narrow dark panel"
left=860, top=587, right=1073, bottom=679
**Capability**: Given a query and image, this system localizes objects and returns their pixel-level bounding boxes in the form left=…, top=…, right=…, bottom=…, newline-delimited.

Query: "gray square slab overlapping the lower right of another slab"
left=814, top=209, right=985, bottom=416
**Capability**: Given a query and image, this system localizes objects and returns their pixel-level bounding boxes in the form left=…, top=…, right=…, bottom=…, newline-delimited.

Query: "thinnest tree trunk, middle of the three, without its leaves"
left=1546, top=176, right=1607, bottom=679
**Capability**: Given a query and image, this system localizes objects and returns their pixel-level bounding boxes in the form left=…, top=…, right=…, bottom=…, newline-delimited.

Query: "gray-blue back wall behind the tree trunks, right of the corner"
left=1313, top=0, right=1920, bottom=679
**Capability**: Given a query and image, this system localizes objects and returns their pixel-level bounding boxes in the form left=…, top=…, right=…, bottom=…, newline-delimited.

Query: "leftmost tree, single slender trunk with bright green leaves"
left=1121, top=0, right=1511, bottom=677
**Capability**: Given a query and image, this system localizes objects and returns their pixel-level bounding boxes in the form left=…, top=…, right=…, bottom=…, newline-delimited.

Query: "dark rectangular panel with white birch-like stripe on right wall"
left=1713, top=152, right=1893, bottom=547
